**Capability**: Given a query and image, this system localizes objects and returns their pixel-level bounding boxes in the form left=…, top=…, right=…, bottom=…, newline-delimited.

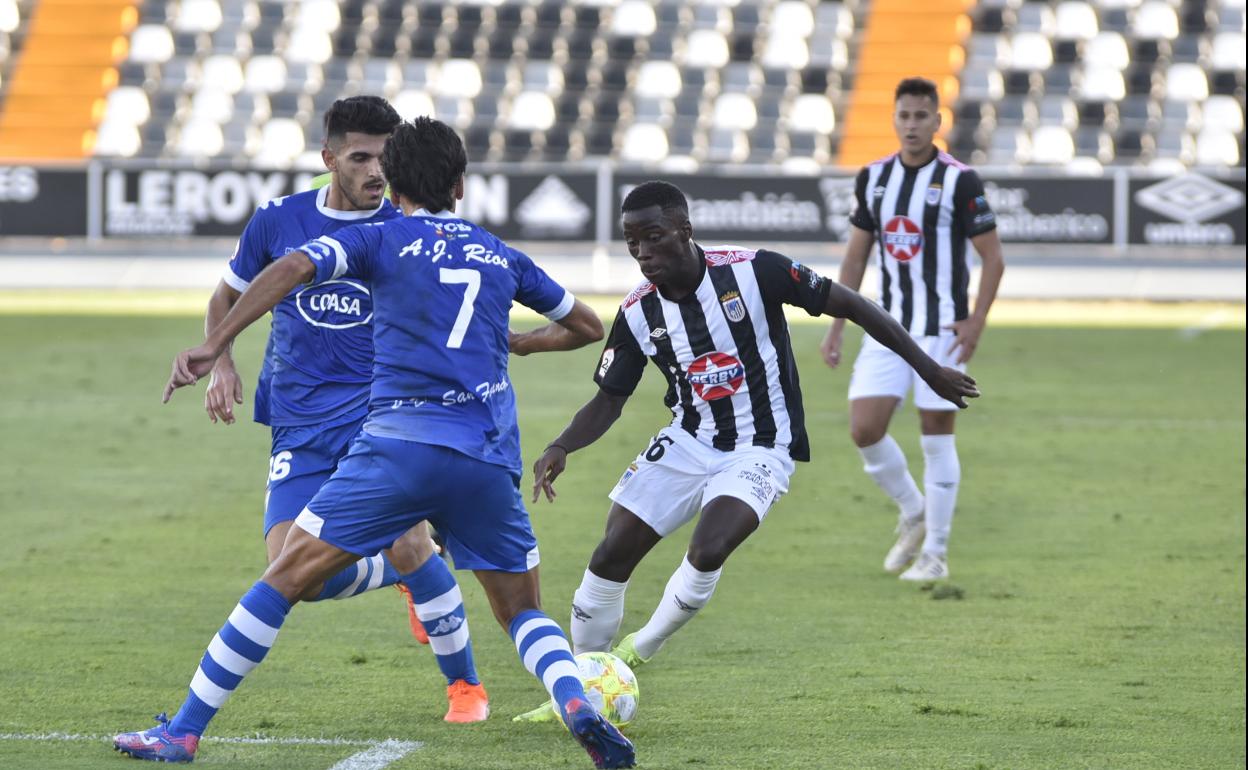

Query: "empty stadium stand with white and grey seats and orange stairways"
left=0, top=0, right=1244, bottom=171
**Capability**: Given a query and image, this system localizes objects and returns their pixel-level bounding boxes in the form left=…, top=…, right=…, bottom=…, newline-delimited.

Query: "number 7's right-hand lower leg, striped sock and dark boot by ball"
left=475, top=569, right=634, bottom=768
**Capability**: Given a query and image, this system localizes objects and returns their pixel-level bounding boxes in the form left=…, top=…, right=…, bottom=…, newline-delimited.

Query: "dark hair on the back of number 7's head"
left=382, top=116, right=468, bottom=211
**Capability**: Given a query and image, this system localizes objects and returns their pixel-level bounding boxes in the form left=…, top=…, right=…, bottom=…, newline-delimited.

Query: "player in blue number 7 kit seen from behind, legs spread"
left=115, top=117, right=634, bottom=768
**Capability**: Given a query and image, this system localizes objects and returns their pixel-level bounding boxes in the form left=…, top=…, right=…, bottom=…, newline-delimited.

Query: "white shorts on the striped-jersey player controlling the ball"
left=610, top=428, right=794, bottom=538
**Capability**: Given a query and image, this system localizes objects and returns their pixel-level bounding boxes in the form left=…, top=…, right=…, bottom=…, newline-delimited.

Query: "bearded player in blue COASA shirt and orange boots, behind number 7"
left=194, top=96, right=489, bottom=723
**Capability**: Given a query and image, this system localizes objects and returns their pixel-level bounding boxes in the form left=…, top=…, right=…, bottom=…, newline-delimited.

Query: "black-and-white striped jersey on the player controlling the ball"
left=594, top=246, right=831, bottom=461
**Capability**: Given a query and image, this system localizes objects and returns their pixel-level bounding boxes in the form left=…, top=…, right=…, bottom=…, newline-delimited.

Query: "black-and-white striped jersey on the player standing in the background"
left=850, top=152, right=997, bottom=337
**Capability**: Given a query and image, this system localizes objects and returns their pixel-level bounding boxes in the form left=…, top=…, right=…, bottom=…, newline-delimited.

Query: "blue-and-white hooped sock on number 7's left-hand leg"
left=168, top=582, right=291, bottom=735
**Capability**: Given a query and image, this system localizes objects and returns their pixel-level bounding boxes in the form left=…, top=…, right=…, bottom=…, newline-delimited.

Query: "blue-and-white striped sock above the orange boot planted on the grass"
left=401, top=555, right=480, bottom=684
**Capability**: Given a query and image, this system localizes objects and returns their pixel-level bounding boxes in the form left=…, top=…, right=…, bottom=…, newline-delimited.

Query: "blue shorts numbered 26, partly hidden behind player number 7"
left=265, top=416, right=364, bottom=538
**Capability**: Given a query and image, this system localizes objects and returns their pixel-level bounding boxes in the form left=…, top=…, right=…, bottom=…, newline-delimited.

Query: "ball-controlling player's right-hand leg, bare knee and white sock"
left=624, top=495, right=759, bottom=666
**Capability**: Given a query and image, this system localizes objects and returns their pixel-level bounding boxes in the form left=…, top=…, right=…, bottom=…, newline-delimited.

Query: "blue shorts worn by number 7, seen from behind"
left=295, top=433, right=538, bottom=573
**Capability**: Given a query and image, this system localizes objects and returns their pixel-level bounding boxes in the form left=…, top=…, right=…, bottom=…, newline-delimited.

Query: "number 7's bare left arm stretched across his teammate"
left=161, top=251, right=316, bottom=403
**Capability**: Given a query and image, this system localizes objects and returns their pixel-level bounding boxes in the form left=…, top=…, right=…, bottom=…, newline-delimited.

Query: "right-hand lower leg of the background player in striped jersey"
left=901, top=409, right=962, bottom=583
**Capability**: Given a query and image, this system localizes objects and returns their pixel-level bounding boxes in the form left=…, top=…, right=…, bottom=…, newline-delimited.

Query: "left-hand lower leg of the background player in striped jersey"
left=850, top=396, right=926, bottom=573
